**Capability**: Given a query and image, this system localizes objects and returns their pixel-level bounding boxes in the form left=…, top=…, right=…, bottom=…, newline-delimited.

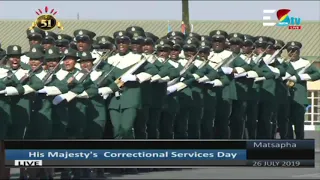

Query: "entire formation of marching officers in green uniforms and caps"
left=0, top=26, right=320, bottom=179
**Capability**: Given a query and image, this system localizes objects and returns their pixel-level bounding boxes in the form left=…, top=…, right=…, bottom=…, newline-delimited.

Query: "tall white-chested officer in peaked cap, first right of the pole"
left=209, top=30, right=249, bottom=139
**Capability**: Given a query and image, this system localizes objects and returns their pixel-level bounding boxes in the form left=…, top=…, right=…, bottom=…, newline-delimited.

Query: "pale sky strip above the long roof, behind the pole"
left=0, top=0, right=320, bottom=22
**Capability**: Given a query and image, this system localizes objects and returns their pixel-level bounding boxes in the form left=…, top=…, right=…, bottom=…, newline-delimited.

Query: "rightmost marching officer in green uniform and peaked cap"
left=284, top=41, right=320, bottom=139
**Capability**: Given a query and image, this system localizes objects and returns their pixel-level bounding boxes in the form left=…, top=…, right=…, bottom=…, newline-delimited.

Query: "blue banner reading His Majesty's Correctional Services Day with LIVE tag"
left=5, top=149, right=247, bottom=167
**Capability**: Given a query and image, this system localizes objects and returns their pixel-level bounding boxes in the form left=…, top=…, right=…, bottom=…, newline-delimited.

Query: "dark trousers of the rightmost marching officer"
left=289, top=101, right=306, bottom=139
